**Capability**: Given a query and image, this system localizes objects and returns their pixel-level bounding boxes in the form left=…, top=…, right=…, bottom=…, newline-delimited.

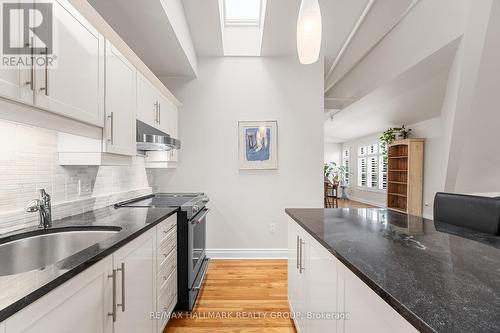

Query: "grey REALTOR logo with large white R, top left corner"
left=1, top=0, right=56, bottom=67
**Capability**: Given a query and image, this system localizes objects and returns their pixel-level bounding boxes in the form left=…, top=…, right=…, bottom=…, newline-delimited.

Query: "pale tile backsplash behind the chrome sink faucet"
left=0, top=121, right=152, bottom=234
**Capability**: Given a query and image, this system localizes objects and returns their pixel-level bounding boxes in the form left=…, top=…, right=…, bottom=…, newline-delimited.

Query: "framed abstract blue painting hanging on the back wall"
left=238, top=120, right=278, bottom=169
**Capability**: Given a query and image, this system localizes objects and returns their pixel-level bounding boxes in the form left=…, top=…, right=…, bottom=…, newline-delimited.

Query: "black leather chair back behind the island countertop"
left=434, top=192, right=500, bottom=235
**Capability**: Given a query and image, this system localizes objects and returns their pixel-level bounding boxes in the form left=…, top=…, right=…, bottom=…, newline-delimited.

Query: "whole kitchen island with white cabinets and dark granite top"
left=286, top=208, right=500, bottom=333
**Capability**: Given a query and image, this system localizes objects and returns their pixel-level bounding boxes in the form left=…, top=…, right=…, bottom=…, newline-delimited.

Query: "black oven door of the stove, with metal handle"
left=188, top=208, right=209, bottom=288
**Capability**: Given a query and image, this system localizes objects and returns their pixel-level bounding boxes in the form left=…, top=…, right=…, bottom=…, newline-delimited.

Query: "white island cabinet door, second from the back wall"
left=304, top=235, right=341, bottom=333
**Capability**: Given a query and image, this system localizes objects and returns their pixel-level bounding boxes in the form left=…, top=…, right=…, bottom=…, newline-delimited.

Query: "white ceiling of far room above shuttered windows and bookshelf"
left=324, top=41, right=458, bottom=142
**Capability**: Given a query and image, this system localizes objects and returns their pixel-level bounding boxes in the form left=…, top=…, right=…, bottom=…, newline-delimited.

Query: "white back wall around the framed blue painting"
left=155, top=57, right=323, bottom=256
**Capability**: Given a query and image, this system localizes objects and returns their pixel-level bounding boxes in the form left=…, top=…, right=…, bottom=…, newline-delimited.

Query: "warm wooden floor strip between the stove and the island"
left=164, top=260, right=296, bottom=333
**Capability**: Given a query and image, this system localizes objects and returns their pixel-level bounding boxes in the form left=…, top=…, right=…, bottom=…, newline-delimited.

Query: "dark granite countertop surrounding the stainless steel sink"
left=0, top=207, right=178, bottom=322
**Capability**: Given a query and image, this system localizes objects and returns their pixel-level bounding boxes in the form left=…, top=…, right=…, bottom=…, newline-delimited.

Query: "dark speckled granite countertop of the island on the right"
left=286, top=208, right=500, bottom=333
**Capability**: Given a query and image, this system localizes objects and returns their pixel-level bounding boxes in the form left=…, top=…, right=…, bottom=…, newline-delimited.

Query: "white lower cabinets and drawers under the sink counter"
left=0, top=214, right=177, bottom=333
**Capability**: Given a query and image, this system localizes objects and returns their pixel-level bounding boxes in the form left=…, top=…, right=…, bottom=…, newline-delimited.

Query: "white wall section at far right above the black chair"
left=446, top=0, right=500, bottom=193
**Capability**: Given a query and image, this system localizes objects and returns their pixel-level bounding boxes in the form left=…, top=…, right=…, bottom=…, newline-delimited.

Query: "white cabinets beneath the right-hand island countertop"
left=288, top=219, right=417, bottom=333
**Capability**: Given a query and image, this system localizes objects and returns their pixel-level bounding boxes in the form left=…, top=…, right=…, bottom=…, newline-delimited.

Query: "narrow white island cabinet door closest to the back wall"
left=288, top=220, right=308, bottom=333
